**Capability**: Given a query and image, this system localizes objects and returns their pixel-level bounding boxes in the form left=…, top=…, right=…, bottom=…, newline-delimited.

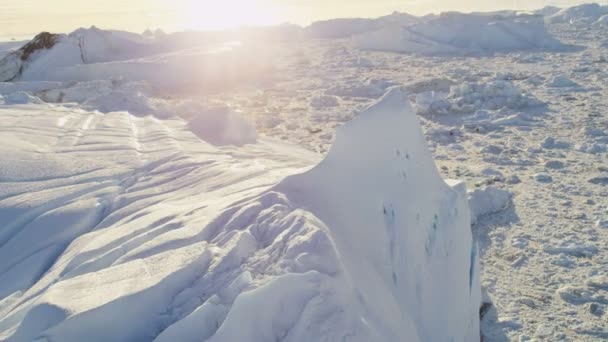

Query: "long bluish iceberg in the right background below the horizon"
left=353, top=13, right=564, bottom=55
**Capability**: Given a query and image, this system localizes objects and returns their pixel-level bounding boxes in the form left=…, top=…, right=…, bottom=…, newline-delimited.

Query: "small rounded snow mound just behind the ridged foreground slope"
left=188, top=107, right=256, bottom=146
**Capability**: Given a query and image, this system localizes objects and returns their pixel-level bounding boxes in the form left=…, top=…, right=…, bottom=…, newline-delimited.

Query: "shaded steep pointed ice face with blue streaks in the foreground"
left=278, top=88, right=480, bottom=341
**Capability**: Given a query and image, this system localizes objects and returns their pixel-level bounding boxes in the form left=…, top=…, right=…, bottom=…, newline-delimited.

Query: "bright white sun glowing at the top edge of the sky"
left=176, top=0, right=280, bottom=30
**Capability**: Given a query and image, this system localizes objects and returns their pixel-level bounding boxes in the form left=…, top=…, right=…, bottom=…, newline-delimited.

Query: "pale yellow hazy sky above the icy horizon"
left=0, top=0, right=608, bottom=39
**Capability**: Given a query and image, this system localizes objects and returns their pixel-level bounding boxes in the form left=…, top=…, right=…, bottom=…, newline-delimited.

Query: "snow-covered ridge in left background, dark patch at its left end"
left=0, top=27, right=271, bottom=90
